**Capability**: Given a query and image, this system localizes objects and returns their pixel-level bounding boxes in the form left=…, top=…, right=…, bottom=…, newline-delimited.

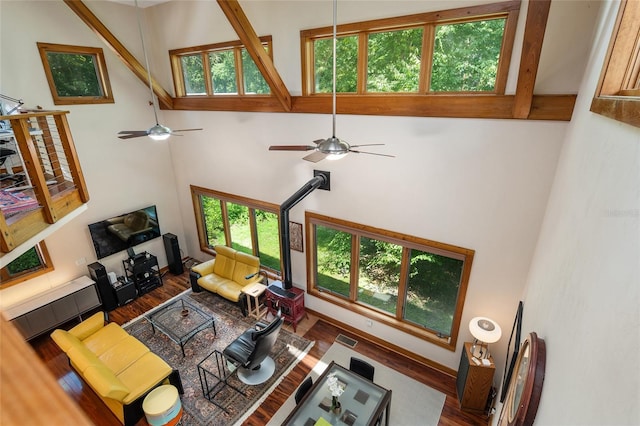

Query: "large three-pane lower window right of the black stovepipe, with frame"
left=306, top=212, right=474, bottom=350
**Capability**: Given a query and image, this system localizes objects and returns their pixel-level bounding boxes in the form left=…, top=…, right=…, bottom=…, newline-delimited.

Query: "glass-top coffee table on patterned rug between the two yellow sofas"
left=145, top=298, right=218, bottom=356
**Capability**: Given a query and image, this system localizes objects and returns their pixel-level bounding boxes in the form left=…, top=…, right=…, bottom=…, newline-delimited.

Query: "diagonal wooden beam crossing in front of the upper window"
left=217, top=0, right=291, bottom=111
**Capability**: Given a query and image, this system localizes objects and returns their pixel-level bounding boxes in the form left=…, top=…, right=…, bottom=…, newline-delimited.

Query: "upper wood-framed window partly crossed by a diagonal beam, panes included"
left=169, top=36, right=272, bottom=97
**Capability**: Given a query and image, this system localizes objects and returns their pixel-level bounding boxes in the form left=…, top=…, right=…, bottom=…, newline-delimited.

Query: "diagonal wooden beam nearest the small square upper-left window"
left=64, top=0, right=173, bottom=109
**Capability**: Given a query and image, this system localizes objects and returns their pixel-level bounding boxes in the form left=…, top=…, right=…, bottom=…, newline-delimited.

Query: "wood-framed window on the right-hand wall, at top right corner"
left=591, top=1, right=640, bottom=127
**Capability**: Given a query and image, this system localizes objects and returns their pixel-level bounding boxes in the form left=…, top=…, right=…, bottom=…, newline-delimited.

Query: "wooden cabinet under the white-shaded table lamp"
left=456, top=342, right=496, bottom=413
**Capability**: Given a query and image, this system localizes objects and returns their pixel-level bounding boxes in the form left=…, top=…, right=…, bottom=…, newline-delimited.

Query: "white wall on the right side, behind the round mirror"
left=523, top=2, right=640, bottom=425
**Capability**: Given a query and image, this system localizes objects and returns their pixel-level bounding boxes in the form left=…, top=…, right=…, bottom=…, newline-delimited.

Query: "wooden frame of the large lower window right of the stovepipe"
left=305, top=211, right=475, bottom=351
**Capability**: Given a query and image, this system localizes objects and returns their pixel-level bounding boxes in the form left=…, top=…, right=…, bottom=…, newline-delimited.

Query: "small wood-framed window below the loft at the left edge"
left=0, top=241, right=53, bottom=288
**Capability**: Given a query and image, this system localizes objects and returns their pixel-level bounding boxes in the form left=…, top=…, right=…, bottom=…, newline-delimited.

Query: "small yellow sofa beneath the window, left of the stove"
left=189, top=246, right=261, bottom=316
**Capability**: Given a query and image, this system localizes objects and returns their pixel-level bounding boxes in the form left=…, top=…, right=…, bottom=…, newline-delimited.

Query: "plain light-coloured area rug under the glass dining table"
left=268, top=343, right=446, bottom=426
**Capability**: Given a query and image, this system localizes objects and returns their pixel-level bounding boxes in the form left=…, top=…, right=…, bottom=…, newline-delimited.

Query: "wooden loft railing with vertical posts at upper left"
left=0, top=110, right=89, bottom=255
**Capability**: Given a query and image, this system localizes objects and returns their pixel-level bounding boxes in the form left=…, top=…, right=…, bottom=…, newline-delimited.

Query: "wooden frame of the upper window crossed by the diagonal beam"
left=169, top=35, right=273, bottom=99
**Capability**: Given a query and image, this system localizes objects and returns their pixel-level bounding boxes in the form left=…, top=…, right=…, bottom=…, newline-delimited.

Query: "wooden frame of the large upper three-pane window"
left=300, top=0, right=521, bottom=97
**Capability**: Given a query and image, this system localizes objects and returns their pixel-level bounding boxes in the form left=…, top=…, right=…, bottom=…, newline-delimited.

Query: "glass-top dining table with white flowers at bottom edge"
left=282, top=361, right=391, bottom=426
